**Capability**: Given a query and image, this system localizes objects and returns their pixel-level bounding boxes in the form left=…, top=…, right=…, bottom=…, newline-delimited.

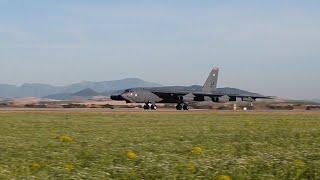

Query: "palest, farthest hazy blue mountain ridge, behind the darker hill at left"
left=0, top=78, right=161, bottom=98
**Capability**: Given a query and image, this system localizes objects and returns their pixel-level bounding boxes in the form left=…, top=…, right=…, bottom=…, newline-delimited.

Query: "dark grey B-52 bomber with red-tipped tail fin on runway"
left=111, top=68, right=272, bottom=110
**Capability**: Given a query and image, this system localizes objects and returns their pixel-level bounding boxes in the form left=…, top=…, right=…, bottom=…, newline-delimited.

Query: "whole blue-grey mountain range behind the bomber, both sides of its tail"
left=0, top=78, right=268, bottom=100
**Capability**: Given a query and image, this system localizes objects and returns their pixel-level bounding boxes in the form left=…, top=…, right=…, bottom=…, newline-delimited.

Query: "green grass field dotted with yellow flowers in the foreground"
left=0, top=112, right=320, bottom=180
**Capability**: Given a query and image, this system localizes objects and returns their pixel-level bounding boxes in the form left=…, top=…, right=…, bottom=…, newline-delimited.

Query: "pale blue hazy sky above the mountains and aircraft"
left=0, top=0, right=320, bottom=99
